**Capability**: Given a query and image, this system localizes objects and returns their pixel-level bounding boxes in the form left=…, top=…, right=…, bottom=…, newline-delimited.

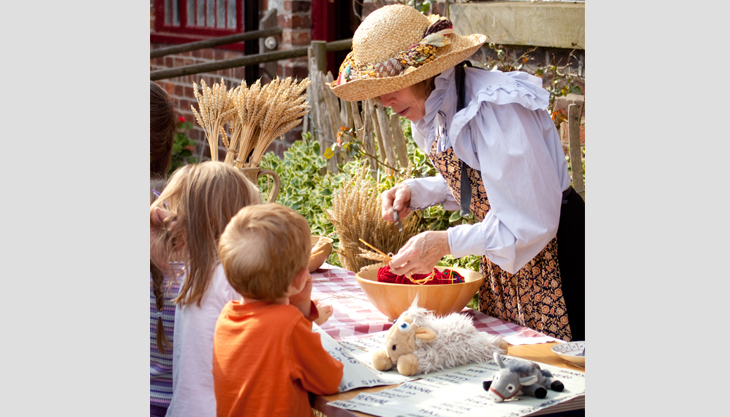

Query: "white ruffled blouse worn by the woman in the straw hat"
left=405, top=68, right=570, bottom=273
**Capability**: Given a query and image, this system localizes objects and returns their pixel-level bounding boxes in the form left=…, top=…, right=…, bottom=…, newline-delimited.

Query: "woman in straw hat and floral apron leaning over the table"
left=330, top=5, right=585, bottom=340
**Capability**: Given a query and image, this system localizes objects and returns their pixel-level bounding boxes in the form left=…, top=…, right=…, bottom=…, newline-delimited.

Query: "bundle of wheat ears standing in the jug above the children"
left=191, top=77, right=311, bottom=168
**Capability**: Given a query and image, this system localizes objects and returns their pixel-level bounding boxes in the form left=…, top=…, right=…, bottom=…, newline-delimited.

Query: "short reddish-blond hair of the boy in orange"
left=218, top=203, right=312, bottom=301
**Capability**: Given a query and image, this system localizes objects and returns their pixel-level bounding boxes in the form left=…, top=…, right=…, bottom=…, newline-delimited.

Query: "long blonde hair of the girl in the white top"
left=151, top=161, right=261, bottom=306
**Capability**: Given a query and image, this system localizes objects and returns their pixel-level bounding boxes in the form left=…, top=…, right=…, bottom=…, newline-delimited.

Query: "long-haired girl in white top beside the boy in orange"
left=150, top=161, right=261, bottom=417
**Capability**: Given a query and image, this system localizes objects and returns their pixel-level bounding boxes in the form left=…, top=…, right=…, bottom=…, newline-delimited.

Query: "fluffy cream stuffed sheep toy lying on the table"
left=372, top=300, right=507, bottom=376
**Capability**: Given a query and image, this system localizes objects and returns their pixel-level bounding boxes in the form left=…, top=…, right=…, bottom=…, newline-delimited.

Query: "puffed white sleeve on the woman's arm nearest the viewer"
left=448, top=102, right=567, bottom=273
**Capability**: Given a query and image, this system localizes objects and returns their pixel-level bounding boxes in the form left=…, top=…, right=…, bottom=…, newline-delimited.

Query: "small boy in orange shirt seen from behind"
left=213, top=203, right=343, bottom=417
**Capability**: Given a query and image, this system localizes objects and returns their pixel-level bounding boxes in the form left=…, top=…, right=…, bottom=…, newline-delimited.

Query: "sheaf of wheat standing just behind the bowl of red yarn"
left=327, top=164, right=417, bottom=272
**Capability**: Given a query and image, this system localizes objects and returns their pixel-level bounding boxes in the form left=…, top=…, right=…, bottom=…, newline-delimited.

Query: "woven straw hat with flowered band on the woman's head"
left=330, top=4, right=487, bottom=101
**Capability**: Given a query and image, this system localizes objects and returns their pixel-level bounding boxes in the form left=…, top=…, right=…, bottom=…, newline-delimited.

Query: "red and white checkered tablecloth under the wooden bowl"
left=311, top=263, right=558, bottom=346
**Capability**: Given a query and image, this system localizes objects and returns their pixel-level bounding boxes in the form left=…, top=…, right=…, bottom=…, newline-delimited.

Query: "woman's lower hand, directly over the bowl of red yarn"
left=390, top=231, right=451, bottom=275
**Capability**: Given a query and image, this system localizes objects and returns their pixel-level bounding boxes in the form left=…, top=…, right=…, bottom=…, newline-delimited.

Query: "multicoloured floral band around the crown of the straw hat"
left=333, top=15, right=454, bottom=85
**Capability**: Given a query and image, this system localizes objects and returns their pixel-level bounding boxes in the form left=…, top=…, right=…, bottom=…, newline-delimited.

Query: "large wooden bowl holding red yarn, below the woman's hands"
left=355, top=266, right=484, bottom=320
